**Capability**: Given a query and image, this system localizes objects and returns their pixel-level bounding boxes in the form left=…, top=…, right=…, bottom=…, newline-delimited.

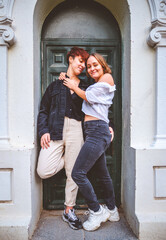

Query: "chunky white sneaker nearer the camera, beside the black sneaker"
left=83, top=206, right=110, bottom=231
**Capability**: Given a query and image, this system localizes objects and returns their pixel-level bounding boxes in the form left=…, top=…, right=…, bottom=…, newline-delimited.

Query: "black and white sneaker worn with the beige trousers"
left=62, top=209, right=82, bottom=230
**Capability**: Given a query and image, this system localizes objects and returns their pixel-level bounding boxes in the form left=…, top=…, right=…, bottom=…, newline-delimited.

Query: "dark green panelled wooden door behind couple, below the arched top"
left=42, top=39, right=121, bottom=209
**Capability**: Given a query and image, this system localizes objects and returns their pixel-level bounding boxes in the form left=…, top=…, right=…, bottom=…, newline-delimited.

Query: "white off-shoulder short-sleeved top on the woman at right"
left=82, top=82, right=116, bottom=123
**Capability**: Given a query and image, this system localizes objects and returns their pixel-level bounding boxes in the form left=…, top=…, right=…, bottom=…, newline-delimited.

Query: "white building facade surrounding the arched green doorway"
left=0, top=0, right=166, bottom=240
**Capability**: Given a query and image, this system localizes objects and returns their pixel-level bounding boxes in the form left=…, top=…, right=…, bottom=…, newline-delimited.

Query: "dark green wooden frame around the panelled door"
left=41, top=38, right=122, bottom=209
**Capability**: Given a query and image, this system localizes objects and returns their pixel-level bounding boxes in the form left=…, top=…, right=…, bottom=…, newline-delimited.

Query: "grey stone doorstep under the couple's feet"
left=31, top=206, right=138, bottom=240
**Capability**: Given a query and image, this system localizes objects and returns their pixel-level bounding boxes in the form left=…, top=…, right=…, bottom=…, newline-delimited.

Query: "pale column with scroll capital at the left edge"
left=0, top=0, right=14, bottom=148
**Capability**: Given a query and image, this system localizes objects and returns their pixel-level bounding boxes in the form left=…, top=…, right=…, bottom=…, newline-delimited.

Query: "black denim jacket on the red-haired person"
left=37, top=80, right=87, bottom=140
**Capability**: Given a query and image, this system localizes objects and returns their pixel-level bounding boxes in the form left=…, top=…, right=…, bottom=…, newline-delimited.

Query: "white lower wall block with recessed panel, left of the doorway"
left=0, top=146, right=42, bottom=240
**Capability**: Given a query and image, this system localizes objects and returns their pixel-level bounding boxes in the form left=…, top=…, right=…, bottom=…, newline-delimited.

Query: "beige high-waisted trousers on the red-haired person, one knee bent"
left=37, top=117, right=83, bottom=206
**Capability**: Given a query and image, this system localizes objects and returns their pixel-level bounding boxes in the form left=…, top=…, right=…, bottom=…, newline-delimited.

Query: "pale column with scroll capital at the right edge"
left=148, top=0, right=166, bottom=148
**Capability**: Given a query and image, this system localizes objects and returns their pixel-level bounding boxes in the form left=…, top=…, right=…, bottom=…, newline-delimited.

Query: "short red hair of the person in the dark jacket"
left=67, top=47, right=89, bottom=64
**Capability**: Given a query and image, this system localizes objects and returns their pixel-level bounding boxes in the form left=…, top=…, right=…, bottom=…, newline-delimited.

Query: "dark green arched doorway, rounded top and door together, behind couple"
left=41, top=0, right=122, bottom=209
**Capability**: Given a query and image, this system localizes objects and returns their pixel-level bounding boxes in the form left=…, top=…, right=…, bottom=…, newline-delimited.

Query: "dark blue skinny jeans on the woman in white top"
left=72, top=120, right=115, bottom=212
